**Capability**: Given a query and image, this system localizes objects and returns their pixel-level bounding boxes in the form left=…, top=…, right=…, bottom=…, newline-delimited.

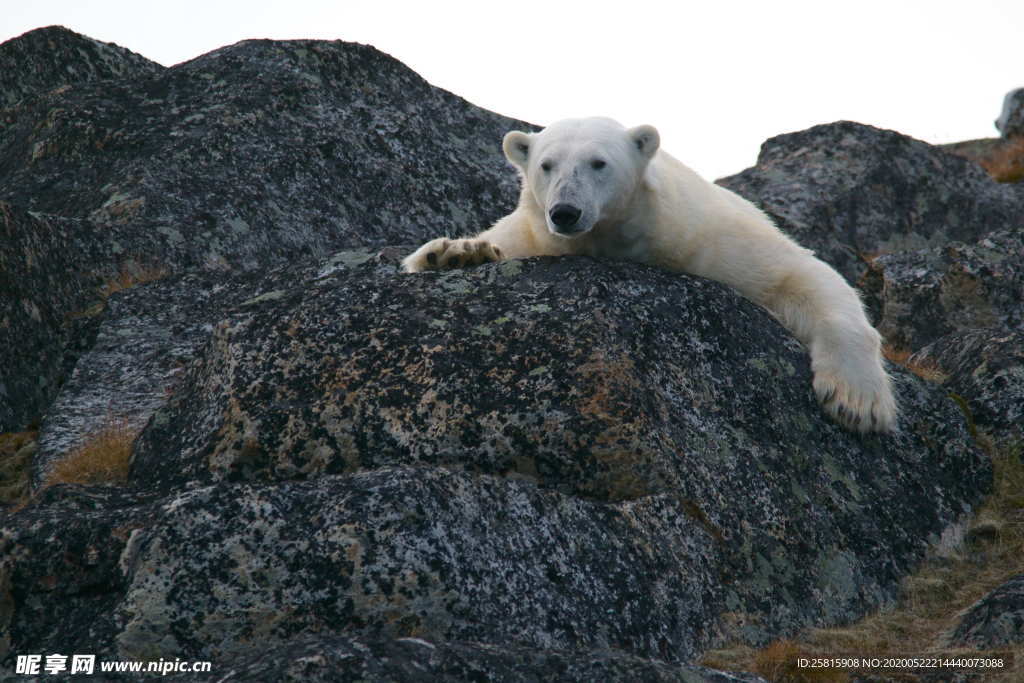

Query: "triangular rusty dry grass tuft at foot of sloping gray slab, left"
left=43, top=418, right=139, bottom=488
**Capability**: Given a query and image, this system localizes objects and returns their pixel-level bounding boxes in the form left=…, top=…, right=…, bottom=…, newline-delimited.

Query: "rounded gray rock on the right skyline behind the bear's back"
left=719, top=122, right=1024, bottom=283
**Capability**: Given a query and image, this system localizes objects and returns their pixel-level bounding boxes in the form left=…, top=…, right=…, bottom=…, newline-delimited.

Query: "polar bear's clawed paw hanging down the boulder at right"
left=814, top=366, right=896, bottom=432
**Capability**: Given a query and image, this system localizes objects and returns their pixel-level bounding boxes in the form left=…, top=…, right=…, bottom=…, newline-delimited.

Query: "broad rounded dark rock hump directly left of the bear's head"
left=0, top=27, right=528, bottom=269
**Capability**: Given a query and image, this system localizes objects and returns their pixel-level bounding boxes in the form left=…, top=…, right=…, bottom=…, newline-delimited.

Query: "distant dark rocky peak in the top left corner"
left=0, top=26, right=164, bottom=109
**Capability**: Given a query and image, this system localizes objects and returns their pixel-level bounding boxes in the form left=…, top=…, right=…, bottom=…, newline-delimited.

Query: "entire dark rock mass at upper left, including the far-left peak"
left=0, top=28, right=530, bottom=432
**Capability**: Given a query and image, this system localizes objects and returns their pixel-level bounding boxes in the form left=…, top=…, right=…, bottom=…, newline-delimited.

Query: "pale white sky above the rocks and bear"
left=0, top=0, right=1024, bottom=178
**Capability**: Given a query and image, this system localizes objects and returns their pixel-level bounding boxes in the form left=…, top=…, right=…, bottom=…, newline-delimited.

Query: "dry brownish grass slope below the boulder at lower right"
left=702, top=435, right=1024, bottom=683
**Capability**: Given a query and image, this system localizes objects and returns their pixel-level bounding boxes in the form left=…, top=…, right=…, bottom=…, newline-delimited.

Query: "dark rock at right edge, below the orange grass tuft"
left=910, top=328, right=1024, bottom=442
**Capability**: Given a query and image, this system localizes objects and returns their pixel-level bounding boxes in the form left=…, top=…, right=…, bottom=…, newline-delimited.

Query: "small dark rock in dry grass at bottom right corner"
left=949, top=573, right=1024, bottom=649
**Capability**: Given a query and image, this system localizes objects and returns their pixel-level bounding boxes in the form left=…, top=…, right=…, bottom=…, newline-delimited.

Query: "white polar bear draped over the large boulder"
left=402, top=118, right=896, bottom=432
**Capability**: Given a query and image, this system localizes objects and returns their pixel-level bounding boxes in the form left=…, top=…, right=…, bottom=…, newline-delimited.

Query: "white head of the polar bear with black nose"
left=502, top=118, right=660, bottom=238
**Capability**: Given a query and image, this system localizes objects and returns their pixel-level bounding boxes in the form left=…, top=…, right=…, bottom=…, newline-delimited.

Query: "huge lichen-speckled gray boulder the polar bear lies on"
left=0, top=252, right=990, bottom=679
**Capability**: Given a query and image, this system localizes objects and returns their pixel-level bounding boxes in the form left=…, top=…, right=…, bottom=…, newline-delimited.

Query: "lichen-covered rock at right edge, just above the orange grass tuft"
left=862, top=231, right=1024, bottom=350
